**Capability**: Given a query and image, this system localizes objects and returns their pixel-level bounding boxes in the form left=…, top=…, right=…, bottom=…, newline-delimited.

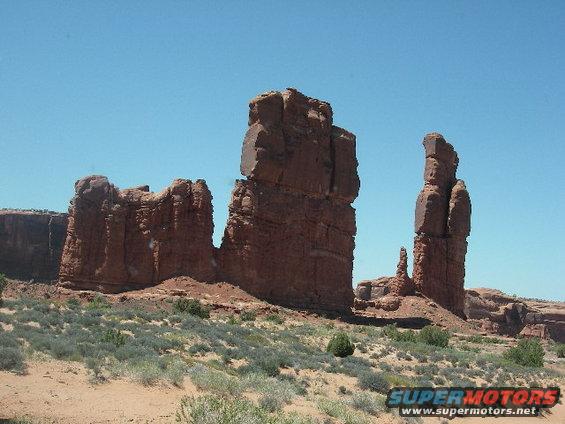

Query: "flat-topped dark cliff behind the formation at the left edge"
left=0, top=209, right=67, bottom=282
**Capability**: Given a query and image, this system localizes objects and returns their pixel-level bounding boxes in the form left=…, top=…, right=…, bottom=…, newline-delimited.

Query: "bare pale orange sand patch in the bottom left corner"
left=0, top=360, right=197, bottom=424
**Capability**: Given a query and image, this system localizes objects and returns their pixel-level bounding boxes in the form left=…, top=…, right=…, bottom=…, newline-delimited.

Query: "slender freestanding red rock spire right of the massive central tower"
left=412, top=133, right=471, bottom=316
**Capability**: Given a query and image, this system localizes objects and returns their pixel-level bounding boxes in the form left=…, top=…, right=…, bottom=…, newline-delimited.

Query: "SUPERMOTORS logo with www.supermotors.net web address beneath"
left=386, top=387, right=560, bottom=417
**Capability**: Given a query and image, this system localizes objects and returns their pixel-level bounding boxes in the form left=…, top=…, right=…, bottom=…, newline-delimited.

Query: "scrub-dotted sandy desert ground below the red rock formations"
left=0, top=278, right=565, bottom=424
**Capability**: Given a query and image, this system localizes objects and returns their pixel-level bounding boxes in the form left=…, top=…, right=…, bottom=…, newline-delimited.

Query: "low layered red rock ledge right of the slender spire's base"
left=465, top=288, right=565, bottom=342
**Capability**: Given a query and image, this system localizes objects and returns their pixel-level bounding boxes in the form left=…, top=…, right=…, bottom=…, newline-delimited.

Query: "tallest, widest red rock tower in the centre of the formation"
left=219, top=89, right=359, bottom=310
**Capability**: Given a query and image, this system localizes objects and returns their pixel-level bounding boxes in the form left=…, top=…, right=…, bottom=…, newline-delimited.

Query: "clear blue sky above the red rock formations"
left=0, top=0, right=565, bottom=300
